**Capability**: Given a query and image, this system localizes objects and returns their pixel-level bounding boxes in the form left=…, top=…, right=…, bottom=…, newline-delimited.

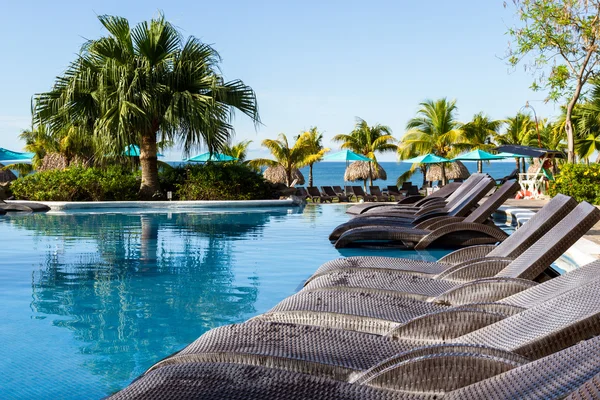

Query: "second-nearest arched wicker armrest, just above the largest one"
left=386, top=308, right=507, bottom=344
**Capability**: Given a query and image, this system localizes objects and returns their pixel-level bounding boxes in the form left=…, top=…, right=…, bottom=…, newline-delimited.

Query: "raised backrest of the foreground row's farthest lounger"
left=488, top=193, right=577, bottom=258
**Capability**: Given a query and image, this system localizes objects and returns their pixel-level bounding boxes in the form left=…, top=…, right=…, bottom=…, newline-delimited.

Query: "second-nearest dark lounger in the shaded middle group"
left=329, top=178, right=496, bottom=242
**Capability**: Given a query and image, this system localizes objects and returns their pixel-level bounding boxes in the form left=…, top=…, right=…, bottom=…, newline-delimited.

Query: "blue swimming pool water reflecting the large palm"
left=0, top=205, right=447, bottom=399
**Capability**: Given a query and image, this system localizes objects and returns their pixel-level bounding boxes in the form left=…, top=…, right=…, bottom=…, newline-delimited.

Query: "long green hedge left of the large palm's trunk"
left=11, top=167, right=140, bottom=201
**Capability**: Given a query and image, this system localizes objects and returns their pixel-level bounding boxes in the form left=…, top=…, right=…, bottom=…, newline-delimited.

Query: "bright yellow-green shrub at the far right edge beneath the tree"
left=548, top=164, right=600, bottom=204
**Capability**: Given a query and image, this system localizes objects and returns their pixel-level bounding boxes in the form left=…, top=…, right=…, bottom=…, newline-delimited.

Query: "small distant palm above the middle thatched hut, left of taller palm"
left=333, top=118, right=398, bottom=187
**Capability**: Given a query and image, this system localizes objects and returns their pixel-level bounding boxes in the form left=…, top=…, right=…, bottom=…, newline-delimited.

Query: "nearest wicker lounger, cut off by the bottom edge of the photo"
left=112, top=337, right=600, bottom=400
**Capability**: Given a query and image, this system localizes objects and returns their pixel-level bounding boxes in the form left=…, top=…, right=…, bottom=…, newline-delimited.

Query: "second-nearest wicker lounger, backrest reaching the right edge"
left=123, top=281, right=600, bottom=395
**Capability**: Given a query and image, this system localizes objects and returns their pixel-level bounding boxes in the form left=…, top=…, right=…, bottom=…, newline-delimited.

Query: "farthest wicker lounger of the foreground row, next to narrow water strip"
left=307, top=194, right=577, bottom=282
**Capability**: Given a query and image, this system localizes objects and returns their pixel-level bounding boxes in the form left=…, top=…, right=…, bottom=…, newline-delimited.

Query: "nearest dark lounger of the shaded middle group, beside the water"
left=330, top=182, right=519, bottom=249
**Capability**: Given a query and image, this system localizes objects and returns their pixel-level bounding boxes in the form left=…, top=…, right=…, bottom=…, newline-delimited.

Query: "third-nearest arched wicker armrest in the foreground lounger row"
left=432, top=277, right=537, bottom=305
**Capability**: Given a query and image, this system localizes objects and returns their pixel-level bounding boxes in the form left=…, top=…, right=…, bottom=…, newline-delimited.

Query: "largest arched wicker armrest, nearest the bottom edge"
left=351, top=345, right=527, bottom=395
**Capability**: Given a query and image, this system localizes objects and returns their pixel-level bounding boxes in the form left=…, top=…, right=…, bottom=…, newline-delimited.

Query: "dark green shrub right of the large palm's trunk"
left=175, top=163, right=271, bottom=200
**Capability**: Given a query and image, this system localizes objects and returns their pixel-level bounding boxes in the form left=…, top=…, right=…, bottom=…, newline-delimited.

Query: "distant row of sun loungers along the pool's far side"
left=298, top=183, right=423, bottom=203
